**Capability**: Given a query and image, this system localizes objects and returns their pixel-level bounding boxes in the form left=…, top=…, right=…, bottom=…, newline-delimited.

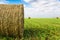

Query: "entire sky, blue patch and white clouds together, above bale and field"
left=0, top=0, right=60, bottom=18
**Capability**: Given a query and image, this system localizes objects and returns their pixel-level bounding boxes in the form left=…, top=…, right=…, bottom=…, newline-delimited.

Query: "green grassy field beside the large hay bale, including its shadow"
left=24, top=18, right=60, bottom=40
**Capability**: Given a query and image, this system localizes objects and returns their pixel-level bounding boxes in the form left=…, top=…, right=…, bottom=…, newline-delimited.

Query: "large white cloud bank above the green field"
left=25, top=0, right=60, bottom=17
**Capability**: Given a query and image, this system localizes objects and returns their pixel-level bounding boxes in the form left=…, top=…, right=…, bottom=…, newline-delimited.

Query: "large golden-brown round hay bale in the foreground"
left=0, top=4, right=24, bottom=38
